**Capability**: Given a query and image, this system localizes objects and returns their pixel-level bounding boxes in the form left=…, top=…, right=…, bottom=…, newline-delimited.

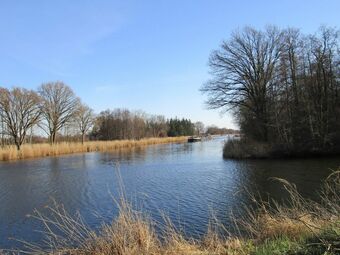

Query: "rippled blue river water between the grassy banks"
left=0, top=137, right=340, bottom=248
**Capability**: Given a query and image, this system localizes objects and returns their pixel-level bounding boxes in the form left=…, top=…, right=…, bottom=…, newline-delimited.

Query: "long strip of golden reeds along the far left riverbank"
left=0, top=136, right=187, bottom=161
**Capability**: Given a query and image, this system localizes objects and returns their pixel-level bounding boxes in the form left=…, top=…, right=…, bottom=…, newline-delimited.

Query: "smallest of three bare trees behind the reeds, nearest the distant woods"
left=75, top=104, right=94, bottom=144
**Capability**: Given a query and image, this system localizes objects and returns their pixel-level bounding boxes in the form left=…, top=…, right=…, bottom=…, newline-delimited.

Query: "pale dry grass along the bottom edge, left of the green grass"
left=11, top=200, right=247, bottom=255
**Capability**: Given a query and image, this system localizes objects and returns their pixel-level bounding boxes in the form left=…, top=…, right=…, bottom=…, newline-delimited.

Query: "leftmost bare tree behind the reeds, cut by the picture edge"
left=0, top=88, right=41, bottom=150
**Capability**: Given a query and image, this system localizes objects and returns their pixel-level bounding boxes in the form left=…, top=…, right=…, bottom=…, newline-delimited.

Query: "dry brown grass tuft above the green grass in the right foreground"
left=237, top=170, right=340, bottom=243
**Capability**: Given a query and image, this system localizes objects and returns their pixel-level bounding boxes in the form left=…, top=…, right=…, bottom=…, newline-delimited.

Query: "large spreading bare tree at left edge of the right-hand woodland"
left=201, top=27, right=283, bottom=141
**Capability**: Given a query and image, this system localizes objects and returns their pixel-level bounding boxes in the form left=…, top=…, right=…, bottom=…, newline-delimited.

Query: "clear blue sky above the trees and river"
left=0, top=0, right=340, bottom=127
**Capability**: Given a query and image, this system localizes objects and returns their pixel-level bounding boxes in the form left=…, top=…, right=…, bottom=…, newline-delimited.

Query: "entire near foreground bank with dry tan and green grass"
left=4, top=171, right=340, bottom=255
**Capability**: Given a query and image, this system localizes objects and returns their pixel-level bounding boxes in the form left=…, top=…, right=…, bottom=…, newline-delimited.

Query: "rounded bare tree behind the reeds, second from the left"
left=38, top=81, right=80, bottom=144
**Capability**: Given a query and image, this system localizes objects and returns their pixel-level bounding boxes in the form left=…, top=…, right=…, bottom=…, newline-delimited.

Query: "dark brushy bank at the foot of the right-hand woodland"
left=223, top=138, right=340, bottom=159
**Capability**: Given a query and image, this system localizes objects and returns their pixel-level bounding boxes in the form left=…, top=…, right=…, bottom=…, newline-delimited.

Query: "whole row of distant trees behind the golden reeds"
left=0, top=81, right=199, bottom=150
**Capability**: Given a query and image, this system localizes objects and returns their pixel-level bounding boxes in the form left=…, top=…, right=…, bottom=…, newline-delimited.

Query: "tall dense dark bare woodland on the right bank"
left=201, top=26, right=340, bottom=155
